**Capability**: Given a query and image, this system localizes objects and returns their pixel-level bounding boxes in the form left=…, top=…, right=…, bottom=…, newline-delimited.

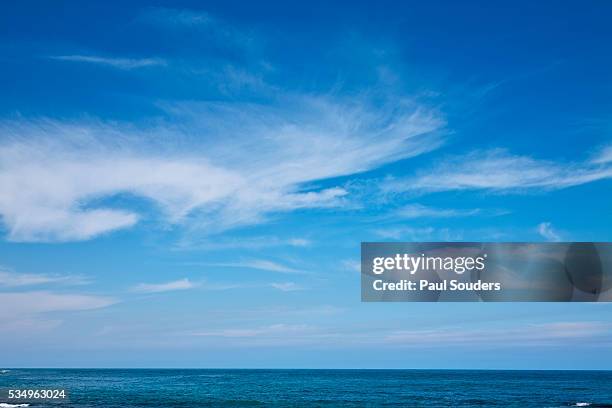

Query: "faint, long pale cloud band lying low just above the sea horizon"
left=181, top=321, right=612, bottom=349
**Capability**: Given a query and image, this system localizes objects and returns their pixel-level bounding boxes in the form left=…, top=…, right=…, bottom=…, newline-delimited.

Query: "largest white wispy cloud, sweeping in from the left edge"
left=0, top=96, right=444, bottom=243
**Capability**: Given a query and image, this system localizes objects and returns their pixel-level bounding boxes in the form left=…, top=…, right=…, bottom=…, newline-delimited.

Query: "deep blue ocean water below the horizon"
left=0, top=369, right=612, bottom=408
